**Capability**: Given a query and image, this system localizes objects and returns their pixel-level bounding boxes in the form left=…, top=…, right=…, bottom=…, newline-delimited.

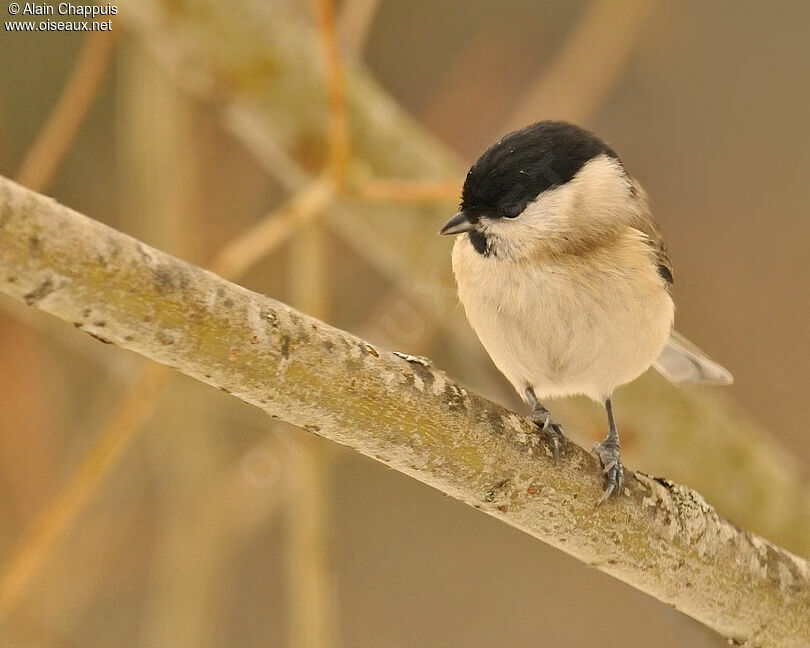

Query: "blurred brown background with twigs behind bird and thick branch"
left=0, top=0, right=810, bottom=648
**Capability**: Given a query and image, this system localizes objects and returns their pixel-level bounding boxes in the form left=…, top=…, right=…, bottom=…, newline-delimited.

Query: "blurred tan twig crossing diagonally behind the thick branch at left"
left=0, top=180, right=332, bottom=620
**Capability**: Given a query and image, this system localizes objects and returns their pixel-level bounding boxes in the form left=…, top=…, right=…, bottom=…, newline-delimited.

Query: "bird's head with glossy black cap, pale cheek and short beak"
left=440, top=121, right=645, bottom=259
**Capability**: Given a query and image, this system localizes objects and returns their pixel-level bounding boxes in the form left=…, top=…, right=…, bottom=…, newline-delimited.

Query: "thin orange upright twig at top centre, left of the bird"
left=316, top=0, right=349, bottom=188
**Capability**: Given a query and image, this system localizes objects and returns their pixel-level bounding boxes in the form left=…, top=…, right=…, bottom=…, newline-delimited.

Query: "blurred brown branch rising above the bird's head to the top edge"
left=501, top=0, right=658, bottom=132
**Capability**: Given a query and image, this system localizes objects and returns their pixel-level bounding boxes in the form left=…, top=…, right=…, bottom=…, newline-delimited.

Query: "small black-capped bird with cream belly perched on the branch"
left=440, top=121, right=732, bottom=503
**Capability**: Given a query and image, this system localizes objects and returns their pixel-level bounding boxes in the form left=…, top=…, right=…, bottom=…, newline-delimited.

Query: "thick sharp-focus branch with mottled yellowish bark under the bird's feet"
left=0, top=178, right=810, bottom=646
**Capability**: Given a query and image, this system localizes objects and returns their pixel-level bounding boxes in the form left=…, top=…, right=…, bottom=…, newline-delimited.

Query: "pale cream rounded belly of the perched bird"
left=452, top=248, right=674, bottom=400
